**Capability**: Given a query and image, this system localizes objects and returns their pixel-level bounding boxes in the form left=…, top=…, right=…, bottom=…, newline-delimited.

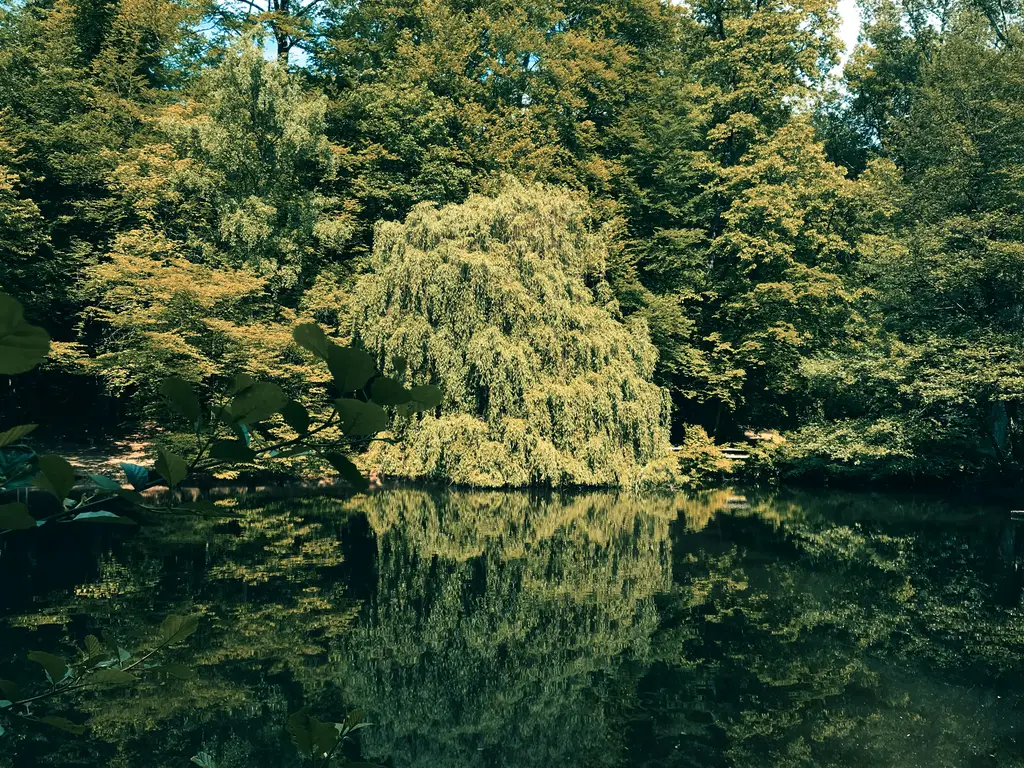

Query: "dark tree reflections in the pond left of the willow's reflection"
left=0, top=497, right=357, bottom=768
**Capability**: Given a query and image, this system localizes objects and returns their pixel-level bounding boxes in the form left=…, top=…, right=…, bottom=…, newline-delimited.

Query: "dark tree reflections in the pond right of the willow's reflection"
left=629, top=495, right=1024, bottom=768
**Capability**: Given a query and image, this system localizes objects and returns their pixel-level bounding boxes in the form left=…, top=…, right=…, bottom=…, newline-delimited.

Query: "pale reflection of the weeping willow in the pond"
left=340, top=492, right=675, bottom=768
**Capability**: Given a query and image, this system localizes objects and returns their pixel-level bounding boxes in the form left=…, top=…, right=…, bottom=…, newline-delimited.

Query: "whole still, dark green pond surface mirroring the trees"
left=0, top=490, right=1024, bottom=768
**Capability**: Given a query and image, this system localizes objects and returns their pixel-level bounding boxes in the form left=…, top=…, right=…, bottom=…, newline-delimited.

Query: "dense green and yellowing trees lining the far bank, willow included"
left=0, top=0, right=1024, bottom=484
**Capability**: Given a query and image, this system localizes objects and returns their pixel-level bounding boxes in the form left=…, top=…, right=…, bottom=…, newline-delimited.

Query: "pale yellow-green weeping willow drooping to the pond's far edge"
left=358, top=182, right=675, bottom=486
